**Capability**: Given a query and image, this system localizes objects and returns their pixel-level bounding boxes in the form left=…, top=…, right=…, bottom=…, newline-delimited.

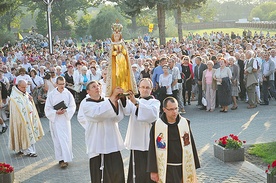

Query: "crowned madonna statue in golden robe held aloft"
left=106, top=23, right=138, bottom=97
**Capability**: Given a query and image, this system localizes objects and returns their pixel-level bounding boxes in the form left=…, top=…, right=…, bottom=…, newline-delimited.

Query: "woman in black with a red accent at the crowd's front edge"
left=181, top=56, right=194, bottom=105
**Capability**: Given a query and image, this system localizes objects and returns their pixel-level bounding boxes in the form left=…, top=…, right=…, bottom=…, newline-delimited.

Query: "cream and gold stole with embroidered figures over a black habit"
left=155, top=117, right=197, bottom=183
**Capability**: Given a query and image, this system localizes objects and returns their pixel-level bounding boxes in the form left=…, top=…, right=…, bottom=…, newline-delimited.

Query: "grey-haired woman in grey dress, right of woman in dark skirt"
left=229, top=57, right=240, bottom=110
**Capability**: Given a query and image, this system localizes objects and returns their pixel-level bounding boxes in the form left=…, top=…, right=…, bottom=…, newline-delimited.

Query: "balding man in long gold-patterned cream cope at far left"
left=9, top=80, right=44, bottom=157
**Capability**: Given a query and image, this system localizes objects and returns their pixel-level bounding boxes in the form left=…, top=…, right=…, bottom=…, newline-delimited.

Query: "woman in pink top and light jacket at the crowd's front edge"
left=202, top=60, right=217, bottom=112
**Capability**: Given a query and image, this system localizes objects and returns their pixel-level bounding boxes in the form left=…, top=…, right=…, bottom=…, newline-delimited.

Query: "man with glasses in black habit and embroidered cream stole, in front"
left=147, top=97, right=200, bottom=182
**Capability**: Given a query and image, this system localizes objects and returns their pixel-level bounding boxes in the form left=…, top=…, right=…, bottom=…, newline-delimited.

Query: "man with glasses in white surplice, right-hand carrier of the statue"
left=122, top=78, right=160, bottom=183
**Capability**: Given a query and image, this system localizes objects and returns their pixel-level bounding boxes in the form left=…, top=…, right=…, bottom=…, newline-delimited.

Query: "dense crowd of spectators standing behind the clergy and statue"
left=0, top=30, right=276, bottom=119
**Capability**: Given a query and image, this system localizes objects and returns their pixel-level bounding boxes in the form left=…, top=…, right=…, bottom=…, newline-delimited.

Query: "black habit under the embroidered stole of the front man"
left=147, top=113, right=200, bottom=183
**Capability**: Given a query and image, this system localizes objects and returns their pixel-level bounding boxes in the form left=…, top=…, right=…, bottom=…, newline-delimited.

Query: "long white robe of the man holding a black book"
left=45, top=88, right=76, bottom=162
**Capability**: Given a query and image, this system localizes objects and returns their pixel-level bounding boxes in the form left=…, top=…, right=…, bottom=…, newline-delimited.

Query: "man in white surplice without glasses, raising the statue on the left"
left=78, top=81, right=125, bottom=183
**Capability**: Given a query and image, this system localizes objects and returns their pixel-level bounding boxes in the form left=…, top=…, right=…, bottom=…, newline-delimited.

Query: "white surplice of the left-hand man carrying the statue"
left=78, top=98, right=125, bottom=158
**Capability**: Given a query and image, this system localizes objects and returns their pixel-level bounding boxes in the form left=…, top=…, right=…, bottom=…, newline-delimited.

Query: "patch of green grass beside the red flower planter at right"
left=248, top=142, right=276, bottom=163
